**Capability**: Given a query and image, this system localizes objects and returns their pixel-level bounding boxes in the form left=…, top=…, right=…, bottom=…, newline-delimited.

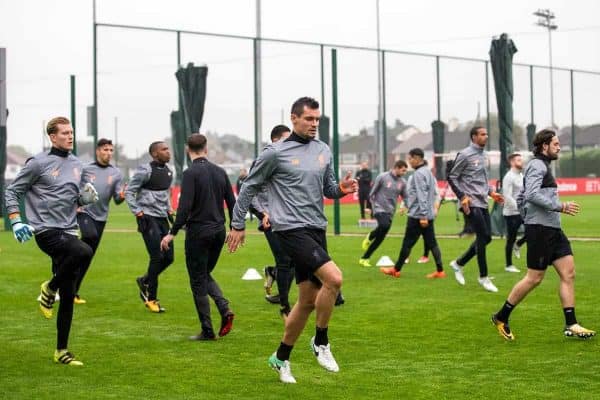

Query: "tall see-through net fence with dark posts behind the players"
left=86, top=25, right=600, bottom=185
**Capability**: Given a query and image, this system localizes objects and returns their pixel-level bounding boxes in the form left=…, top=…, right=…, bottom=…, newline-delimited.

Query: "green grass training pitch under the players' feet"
left=0, top=197, right=600, bottom=399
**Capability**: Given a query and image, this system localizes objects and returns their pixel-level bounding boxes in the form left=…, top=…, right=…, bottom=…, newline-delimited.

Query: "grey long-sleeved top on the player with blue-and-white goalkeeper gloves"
left=4, top=148, right=83, bottom=234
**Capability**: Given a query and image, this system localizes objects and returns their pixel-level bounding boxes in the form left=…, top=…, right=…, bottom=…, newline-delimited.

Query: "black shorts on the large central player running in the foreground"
left=275, top=228, right=331, bottom=287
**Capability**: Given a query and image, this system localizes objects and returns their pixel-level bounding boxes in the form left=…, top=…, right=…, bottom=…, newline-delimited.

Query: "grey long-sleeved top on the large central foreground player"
left=231, top=133, right=344, bottom=231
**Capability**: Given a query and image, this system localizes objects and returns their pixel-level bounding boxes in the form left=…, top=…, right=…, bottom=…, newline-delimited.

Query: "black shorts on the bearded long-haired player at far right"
left=525, top=225, right=573, bottom=271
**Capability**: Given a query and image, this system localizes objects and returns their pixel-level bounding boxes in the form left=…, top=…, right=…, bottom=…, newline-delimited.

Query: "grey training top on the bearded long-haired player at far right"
left=517, top=155, right=562, bottom=228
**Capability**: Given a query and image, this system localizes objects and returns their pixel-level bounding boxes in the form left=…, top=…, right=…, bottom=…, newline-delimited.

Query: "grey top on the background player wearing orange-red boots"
left=404, top=164, right=438, bottom=220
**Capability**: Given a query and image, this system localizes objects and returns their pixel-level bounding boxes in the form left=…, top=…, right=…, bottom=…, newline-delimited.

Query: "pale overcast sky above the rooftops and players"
left=0, top=0, right=600, bottom=156
